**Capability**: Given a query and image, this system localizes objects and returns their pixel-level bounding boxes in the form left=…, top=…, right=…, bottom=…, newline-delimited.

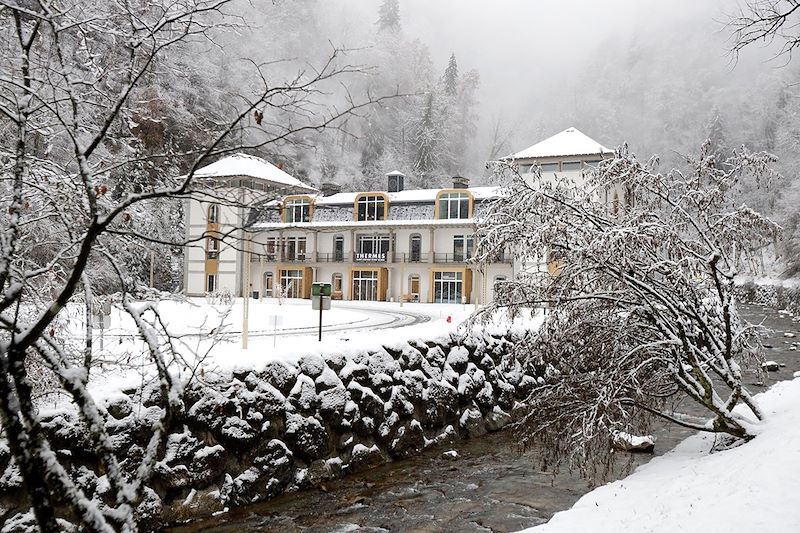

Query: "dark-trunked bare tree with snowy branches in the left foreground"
left=0, top=0, right=390, bottom=532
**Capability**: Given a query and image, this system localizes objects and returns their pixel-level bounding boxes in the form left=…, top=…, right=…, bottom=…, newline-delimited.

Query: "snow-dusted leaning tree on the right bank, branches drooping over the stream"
left=477, top=144, right=778, bottom=476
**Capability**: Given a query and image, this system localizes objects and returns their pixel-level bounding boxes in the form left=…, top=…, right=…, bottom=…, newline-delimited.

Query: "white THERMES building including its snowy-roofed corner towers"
left=184, top=128, right=612, bottom=304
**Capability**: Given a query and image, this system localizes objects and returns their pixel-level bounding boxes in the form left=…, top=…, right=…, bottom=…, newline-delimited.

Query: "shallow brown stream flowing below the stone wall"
left=165, top=306, right=800, bottom=533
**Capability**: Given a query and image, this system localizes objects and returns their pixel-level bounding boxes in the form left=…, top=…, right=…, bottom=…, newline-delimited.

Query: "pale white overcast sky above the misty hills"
left=336, top=0, right=749, bottom=131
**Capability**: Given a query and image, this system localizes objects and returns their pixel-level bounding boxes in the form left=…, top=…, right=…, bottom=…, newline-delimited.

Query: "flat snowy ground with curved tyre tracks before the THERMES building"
left=65, top=298, right=541, bottom=404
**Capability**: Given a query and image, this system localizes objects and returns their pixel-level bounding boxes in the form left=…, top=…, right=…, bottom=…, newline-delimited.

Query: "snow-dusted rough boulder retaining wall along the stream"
left=0, top=333, right=541, bottom=532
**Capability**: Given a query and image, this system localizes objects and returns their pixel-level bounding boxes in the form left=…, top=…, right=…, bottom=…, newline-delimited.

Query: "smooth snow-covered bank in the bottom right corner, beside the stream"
left=525, top=379, right=800, bottom=533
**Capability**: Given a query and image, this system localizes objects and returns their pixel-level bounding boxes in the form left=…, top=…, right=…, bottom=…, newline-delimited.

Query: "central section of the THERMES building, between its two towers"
left=248, top=176, right=512, bottom=304
